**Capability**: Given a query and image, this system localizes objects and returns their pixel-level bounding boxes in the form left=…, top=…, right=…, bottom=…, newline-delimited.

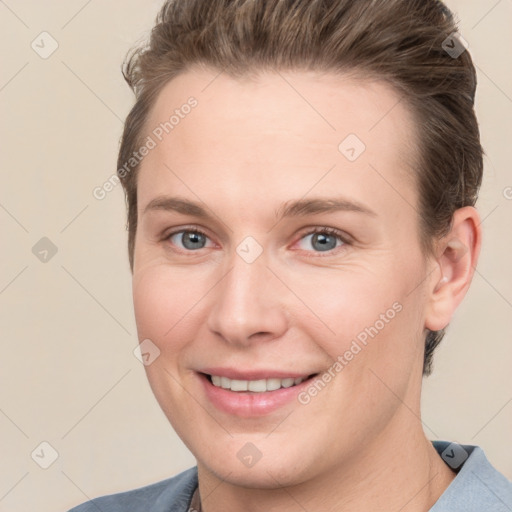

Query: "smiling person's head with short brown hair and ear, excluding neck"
left=118, top=0, right=482, bottom=483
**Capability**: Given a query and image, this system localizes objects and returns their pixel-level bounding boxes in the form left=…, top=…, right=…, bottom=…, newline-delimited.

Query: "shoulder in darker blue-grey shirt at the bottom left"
left=69, top=466, right=197, bottom=512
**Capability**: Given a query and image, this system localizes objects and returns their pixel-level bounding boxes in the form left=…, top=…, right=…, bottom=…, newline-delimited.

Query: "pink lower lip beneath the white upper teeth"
left=198, top=373, right=316, bottom=418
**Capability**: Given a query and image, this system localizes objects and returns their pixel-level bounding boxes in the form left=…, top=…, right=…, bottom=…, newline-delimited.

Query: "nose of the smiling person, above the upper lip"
left=208, top=249, right=288, bottom=346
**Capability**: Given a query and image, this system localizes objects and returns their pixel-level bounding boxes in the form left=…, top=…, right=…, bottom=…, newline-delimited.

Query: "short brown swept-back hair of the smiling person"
left=118, top=0, right=483, bottom=376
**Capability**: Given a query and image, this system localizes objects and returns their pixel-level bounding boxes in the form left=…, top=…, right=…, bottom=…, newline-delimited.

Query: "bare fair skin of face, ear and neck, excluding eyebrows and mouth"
left=133, top=68, right=481, bottom=512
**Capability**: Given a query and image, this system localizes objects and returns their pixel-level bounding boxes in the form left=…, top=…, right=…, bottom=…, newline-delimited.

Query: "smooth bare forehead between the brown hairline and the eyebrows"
left=138, top=69, right=416, bottom=214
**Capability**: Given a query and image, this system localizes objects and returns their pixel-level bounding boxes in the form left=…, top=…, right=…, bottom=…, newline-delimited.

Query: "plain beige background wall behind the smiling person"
left=0, top=0, right=512, bottom=512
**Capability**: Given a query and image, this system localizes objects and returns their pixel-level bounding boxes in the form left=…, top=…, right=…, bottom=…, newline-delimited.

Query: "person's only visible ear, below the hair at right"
left=425, top=206, right=482, bottom=331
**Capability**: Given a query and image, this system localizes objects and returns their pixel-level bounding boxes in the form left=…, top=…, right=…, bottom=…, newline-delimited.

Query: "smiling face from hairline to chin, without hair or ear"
left=133, top=69, right=427, bottom=487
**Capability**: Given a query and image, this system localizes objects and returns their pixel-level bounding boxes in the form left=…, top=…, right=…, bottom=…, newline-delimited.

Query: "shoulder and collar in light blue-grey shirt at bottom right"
left=430, top=441, right=512, bottom=512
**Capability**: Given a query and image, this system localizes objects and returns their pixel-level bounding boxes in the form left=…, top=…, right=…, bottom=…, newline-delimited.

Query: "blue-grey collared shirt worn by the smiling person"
left=69, top=441, right=512, bottom=512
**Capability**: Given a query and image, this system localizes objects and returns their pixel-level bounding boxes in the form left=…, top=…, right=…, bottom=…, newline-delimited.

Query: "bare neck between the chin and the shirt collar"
left=198, top=407, right=456, bottom=512
